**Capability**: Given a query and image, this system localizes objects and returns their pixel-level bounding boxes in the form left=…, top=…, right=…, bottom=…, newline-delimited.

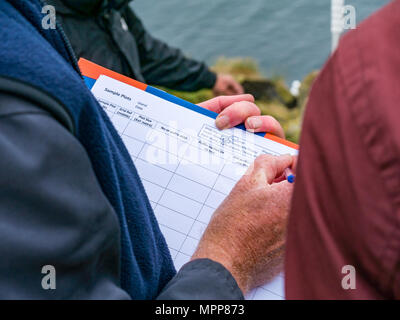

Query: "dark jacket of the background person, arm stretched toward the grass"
left=47, top=0, right=216, bottom=91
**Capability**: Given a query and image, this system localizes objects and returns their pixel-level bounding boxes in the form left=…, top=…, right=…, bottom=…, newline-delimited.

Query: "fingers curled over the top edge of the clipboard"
left=199, top=94, right=285, bottom=138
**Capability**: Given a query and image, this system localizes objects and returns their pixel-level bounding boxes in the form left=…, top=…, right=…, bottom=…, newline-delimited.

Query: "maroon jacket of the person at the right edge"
left=286, top=0, right=400, bottom=299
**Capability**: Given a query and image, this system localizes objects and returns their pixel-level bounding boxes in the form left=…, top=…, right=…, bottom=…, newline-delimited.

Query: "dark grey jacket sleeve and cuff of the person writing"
left=0, top=78, right=243, bottom=299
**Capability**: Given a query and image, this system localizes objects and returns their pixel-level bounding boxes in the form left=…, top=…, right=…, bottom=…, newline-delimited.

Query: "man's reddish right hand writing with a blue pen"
left=192, top=155, right=294, bottom=294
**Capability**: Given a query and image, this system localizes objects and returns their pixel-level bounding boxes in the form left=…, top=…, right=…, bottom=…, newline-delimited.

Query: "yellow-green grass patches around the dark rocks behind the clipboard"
left=159, top=58, right=317, bottom=143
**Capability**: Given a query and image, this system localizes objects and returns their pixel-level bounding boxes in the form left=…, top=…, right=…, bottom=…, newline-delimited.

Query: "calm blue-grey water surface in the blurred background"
left=133, top=0, right=389, bottom=83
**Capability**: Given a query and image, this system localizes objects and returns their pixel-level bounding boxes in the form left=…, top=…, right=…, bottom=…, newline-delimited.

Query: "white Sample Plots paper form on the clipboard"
left=92, top=76, right=297, bottom=300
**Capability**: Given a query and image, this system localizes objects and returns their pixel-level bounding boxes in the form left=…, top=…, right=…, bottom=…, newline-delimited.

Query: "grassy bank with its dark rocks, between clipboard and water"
left=164, top=58, right=318, bottom=143
